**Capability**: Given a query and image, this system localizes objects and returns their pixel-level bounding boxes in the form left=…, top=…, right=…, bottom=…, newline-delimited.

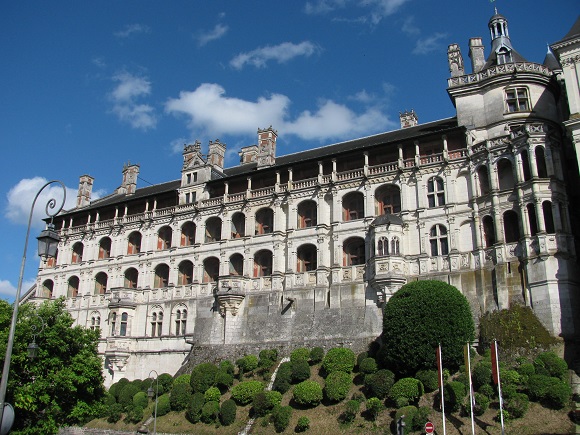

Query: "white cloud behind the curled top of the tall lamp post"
left=4, top=177, right=77, bottom=229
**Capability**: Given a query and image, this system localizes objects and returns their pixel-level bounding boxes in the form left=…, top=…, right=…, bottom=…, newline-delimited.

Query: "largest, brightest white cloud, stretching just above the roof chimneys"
left=165, top=83, right=393, bottom=141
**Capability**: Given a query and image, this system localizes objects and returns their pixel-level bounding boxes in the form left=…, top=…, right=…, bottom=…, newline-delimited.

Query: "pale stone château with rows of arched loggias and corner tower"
left=27, top=14, right=580, bottom=385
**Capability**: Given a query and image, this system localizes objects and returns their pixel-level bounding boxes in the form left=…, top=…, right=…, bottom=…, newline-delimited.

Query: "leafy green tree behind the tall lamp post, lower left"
left=0, top=298, right=105, bottom=435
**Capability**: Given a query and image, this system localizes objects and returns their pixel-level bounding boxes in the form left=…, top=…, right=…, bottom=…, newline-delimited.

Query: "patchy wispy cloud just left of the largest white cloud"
left=110, top=71, right=157, bottom=130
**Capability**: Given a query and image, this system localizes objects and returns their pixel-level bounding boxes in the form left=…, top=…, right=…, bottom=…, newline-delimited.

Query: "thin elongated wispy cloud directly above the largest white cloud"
left=230, top=41, right=320, bottom=69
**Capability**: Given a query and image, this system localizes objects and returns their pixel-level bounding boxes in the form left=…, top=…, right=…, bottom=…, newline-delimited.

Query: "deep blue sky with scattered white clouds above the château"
left=0, top=0, right=580, bottom=301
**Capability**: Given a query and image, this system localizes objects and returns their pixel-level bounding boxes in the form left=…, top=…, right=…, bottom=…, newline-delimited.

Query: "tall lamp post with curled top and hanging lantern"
left=0, top=180, right=66, bottom=431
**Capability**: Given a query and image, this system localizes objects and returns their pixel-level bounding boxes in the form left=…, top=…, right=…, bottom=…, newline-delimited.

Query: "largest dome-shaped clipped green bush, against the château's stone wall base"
left=380, top=280, right=475, bottom=375
